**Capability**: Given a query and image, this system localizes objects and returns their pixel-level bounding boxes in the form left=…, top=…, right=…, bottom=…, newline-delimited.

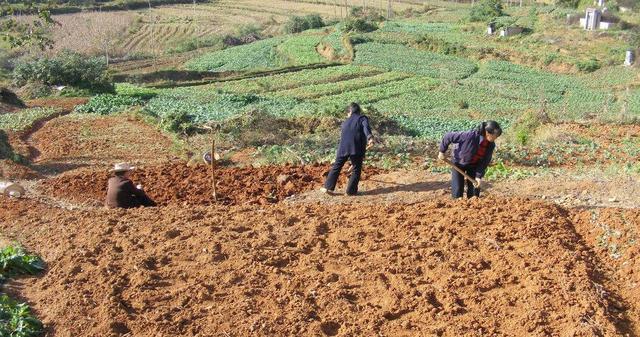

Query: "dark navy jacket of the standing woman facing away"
left=337, top=114, right=372, bottom=157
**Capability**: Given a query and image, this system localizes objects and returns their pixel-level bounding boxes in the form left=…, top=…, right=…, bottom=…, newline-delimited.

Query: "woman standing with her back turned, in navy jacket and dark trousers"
left=320, top=103, right=373, bottom=195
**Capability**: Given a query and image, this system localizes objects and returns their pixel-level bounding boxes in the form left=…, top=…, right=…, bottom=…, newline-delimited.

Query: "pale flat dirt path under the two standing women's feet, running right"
left=292, top=171, right=640, bottom=208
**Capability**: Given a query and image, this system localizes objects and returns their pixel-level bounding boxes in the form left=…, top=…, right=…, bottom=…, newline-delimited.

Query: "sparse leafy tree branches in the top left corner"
left=0, top=3, right=56, bottom=50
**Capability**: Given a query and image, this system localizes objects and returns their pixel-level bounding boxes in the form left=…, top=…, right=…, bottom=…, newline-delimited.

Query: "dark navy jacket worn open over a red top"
left=440, top=130, right=496, bottom=178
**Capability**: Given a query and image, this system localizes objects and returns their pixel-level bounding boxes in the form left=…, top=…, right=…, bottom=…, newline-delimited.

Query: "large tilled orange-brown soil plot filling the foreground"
left=0, top=198, right=629, bottom=337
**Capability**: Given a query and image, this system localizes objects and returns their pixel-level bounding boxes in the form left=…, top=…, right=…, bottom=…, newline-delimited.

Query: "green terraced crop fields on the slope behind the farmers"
left=79, top=22, right=640, bottom=138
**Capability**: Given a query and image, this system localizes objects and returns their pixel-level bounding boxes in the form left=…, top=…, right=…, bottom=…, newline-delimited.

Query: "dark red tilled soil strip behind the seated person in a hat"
left=41, top=162, right=388, bottom=205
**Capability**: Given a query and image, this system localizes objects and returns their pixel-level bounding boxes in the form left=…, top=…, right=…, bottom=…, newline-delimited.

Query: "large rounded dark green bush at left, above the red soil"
left=13, top=51, right=113, bottom=92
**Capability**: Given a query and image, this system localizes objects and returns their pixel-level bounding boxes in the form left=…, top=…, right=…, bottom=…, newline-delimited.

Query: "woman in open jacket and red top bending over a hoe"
left=438, top=121, right=502, bottom=199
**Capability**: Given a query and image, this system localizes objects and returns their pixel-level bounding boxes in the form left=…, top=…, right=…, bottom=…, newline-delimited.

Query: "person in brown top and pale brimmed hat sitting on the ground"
left=105, top=163, right=156, bottom=208
